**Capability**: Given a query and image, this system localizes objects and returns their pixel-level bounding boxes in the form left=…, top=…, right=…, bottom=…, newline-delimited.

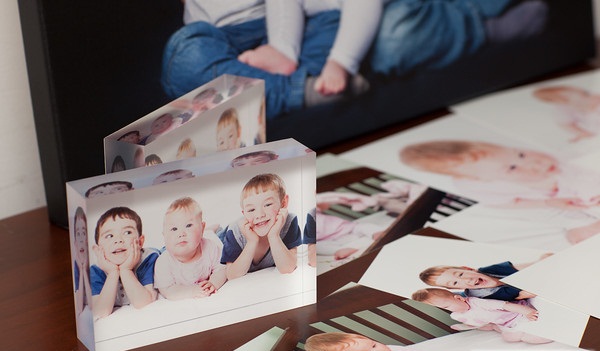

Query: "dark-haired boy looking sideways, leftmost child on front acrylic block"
left=90, top=207, right=158, bottom=318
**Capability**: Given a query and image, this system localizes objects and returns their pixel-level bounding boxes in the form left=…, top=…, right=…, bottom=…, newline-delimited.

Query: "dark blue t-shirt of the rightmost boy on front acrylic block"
left=221, top=214, right=302, bottom=272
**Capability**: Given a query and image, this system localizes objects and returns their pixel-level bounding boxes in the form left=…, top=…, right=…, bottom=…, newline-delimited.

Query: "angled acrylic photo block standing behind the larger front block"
left=104, top=75, right=266, bottom=173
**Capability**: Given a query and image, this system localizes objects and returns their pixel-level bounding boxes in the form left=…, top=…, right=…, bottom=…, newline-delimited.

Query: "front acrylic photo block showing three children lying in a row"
left=66, top=139, right=316, bottom=351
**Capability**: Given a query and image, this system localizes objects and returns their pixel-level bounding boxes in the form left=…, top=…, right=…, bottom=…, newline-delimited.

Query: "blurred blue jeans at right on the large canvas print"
left=369, top=0, right=513, bottom=75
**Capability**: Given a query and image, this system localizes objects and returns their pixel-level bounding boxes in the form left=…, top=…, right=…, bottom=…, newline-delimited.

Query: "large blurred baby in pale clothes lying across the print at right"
left=400, top=140, right=600, bottom=209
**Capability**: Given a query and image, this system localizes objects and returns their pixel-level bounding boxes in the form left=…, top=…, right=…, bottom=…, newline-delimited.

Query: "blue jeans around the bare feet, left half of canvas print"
left=161, top=11, right=339, bottom=118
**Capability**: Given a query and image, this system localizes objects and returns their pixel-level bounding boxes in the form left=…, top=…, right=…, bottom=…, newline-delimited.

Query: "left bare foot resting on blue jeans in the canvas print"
left=238, top=44, right=296, bottom=76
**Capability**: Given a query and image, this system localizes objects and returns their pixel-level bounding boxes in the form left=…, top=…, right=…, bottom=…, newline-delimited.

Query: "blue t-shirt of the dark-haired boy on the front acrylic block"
left=90, top=248, right=159, bottom=306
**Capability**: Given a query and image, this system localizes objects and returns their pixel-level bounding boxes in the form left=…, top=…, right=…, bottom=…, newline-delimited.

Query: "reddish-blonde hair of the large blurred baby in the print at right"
left=400, top=140, right=498, bottom=175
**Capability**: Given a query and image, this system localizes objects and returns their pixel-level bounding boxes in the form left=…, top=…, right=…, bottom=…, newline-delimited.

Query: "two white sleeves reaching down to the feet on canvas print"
left=266, top=0, right=388, bottom=74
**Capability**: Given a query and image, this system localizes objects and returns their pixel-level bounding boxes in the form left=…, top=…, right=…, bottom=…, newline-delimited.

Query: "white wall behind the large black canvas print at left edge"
left=0, top=0, right=600, bottom=219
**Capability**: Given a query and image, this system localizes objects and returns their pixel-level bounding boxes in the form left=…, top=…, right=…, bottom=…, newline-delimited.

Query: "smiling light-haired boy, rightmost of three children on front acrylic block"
left=221, top=173, right=302, bottom=279
